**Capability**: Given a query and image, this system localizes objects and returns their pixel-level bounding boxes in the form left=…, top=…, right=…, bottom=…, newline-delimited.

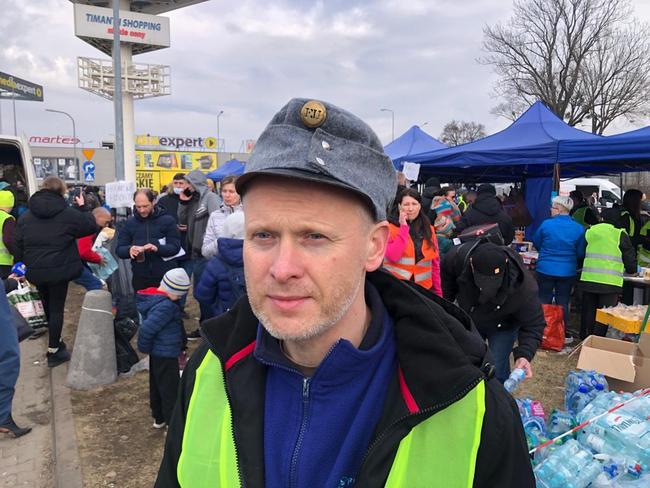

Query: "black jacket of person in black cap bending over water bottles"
left=440, top=242, right=546, bottom=361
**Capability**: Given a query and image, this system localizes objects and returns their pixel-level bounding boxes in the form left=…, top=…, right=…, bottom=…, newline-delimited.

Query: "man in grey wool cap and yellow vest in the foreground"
left=156, top=99, right=534, bottom=488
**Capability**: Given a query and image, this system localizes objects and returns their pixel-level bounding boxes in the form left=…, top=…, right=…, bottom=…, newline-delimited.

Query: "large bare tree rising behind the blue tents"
left=480, top=0, right=650, bottom=133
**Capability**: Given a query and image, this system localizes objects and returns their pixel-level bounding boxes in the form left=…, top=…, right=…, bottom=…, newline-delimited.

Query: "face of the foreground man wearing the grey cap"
left=244, top=178, right=387, bottom=341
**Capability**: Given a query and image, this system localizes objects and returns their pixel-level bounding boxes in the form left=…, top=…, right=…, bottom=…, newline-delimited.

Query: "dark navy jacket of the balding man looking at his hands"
left=115, top=205, right=181, bottom=279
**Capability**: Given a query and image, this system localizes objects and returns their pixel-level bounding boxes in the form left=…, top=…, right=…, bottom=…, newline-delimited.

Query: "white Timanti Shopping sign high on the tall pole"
left=74, top=3, right=170, bottom=47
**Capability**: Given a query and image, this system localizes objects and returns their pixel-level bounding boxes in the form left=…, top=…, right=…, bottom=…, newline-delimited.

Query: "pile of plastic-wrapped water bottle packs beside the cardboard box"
left=517, top=371, right=650, bottom=488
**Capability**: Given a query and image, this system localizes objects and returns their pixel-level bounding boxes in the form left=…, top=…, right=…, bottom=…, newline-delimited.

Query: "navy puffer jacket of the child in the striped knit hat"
left=137, top=288, right=183, bottom=358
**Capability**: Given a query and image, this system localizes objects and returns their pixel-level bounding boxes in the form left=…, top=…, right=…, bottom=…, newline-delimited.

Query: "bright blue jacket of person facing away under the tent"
left=533, top=215, right=587, bottom=277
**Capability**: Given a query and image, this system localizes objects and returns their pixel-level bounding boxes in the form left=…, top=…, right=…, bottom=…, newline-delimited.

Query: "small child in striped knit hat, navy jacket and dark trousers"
left=137, top=268, right=190, bottom=429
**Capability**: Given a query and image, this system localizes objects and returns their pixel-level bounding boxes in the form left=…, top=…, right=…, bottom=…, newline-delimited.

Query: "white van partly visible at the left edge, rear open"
left=0, top=135, right=38, bottom=215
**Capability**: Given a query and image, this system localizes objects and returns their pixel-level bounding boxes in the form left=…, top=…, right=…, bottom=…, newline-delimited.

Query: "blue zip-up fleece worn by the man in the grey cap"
left=255, top=282, right=397, bottom=488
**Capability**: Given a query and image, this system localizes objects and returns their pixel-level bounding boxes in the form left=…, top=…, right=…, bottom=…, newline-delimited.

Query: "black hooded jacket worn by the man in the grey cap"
left=155, top=271, right=535, bottom=488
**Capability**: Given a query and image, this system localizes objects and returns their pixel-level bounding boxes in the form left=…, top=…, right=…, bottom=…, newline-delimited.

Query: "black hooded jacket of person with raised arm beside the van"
left=14, top=190, right=99, bottom=285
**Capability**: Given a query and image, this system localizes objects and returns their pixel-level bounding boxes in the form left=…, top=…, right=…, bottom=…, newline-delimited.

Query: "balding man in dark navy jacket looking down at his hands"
left=116, top=188, right=181, bottom=291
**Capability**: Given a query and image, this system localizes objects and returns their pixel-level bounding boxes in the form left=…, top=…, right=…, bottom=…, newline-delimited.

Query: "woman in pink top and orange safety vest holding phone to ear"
left=384, top=188, right=442, bottom=296
